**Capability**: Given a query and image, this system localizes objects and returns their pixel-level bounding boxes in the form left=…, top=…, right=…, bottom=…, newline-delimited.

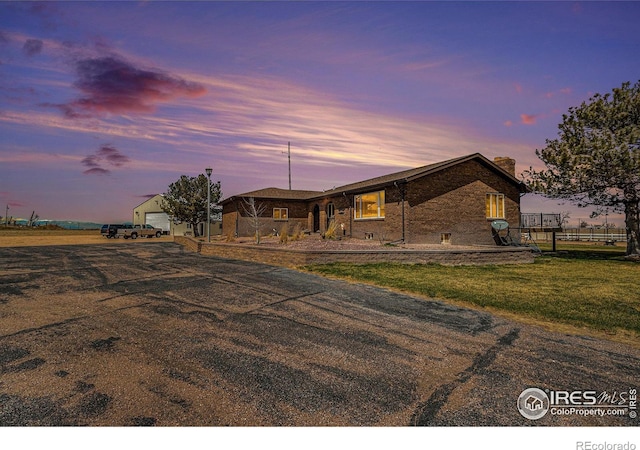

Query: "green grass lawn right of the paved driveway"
left=306, top=243, right=640, bottom=346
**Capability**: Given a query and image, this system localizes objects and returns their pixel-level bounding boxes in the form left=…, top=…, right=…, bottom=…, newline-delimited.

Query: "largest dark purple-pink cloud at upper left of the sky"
left=55, top=56, right=206, bottom=118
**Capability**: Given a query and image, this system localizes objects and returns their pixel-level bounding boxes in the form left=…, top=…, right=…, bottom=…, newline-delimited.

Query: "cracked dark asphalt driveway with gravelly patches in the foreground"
left=0, top=242, right=640, bottom=426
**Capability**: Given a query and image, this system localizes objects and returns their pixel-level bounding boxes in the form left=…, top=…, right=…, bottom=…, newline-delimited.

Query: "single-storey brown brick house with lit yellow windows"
left=220, top=153, right=527, bottom=245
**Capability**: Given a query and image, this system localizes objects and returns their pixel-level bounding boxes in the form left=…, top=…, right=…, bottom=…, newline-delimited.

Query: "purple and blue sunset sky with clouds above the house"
left=0, top=1, right=640, bottom=224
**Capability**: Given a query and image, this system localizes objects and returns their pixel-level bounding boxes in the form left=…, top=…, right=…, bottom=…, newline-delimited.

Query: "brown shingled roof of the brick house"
left=221, top=153, right=527, bottom=203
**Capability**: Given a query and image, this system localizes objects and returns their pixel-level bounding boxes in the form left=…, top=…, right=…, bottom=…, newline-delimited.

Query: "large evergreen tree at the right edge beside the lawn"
left=525, top=81, right=640, bottom=259
